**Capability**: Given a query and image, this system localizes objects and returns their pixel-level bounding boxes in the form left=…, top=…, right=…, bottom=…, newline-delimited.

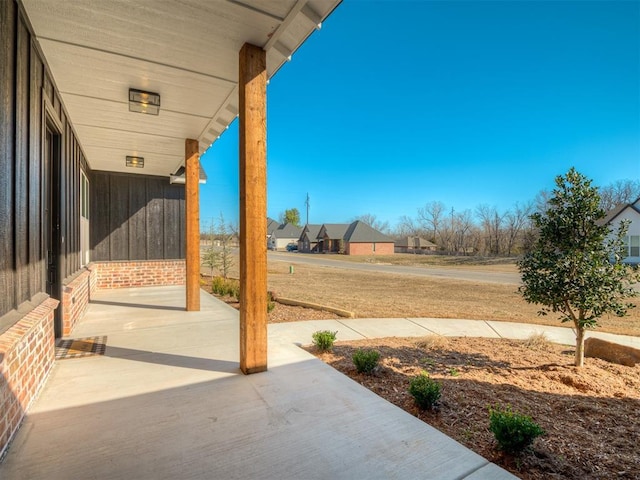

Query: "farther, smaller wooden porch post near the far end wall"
left=184, top=138, right=200, bottom=312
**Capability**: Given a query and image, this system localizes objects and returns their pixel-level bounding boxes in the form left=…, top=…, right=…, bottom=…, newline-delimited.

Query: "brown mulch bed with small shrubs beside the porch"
left=310, top=336, right=640, bottom=480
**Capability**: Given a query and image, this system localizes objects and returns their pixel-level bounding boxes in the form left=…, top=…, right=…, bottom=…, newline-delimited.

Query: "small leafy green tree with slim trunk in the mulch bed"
left=518, top=168, right=638, bottom=367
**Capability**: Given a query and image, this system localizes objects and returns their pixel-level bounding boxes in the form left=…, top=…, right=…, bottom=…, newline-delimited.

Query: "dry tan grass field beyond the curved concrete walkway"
left=268, top=255, right=640, bottom=335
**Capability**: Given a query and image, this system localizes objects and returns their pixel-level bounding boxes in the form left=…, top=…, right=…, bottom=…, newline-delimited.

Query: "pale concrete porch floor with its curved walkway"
left=0, top=287, right=638, bottom=480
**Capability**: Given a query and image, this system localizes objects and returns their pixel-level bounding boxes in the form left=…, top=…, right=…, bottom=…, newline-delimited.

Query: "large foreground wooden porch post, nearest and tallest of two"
left=239, top=43, right=267, bottom=374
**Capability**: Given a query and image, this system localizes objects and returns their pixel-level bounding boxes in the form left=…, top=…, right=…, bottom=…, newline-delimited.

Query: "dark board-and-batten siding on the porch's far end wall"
left=90, top=171, right=185, bottom=261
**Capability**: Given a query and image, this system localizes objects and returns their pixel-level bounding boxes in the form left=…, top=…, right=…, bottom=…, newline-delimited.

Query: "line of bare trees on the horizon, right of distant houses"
left=355, top=180, right=640, bottom=256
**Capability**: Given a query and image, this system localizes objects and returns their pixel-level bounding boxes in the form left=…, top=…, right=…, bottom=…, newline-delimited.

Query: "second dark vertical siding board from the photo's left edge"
left=14, top=19, right=30, bottom=305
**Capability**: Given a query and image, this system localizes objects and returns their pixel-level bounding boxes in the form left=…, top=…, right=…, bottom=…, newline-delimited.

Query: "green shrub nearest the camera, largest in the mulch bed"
left=489, top=405, right=545, bottom=453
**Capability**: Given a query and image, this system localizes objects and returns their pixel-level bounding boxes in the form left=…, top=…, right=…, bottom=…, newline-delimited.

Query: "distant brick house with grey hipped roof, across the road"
left=317, top=220, right=394, bottom=255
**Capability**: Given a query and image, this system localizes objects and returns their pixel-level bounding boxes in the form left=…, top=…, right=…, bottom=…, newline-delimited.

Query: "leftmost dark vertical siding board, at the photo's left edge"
left=0, top=2, right=16, bottom=316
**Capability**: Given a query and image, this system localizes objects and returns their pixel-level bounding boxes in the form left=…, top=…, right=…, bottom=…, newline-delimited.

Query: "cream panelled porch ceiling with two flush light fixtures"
left=21, top=0, right=341, bottom=176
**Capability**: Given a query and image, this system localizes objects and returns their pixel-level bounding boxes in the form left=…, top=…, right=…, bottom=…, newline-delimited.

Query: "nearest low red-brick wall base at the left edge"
left=0, top=298, right=58, bottom=458
